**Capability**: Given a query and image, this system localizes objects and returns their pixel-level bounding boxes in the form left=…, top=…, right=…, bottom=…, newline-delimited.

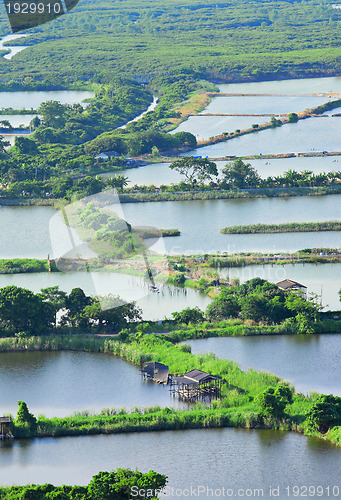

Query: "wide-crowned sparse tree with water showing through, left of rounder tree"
left=169, top=156, right=218, bottom=186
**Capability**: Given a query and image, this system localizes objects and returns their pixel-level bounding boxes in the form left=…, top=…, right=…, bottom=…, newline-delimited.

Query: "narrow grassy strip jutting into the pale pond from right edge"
left=220, top=221, right=341, bottom=234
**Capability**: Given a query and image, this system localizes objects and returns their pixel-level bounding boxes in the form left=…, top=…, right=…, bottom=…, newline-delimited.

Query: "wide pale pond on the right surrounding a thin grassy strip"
left=122, top=195, right=341, bottom=254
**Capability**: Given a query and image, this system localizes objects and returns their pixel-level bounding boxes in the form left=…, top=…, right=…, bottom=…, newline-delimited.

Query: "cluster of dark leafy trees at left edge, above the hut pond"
left=0, top=285, right=141, bottom=338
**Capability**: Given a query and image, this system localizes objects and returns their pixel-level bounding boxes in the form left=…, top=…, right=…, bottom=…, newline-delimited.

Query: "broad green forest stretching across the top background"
left=0, top=0, right=340, bottom=88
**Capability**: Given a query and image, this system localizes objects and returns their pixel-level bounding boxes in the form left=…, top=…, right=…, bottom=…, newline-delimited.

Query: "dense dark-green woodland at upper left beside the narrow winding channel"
left=0, top=76, right=200, bottom=199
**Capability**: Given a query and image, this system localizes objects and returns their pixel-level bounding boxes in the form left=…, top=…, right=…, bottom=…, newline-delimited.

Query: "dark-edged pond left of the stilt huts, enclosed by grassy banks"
left=0, top=351, right=184, bottom=417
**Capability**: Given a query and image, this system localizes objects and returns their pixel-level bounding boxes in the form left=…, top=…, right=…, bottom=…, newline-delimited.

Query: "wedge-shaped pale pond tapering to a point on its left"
left=186, top=117, right=341, bottom=158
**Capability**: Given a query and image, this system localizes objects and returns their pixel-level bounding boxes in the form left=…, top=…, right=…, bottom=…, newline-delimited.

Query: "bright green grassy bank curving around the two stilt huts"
left=0, top=336, right=341, bottom=444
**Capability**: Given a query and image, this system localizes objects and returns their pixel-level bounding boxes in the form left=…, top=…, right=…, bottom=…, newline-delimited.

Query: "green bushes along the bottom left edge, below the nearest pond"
left=0, top=468, right=167, bottom=500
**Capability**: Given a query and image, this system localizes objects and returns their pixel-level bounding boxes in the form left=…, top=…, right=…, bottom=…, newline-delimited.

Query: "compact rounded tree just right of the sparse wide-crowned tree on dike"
left=222, top=158, right=260, bottom=189
